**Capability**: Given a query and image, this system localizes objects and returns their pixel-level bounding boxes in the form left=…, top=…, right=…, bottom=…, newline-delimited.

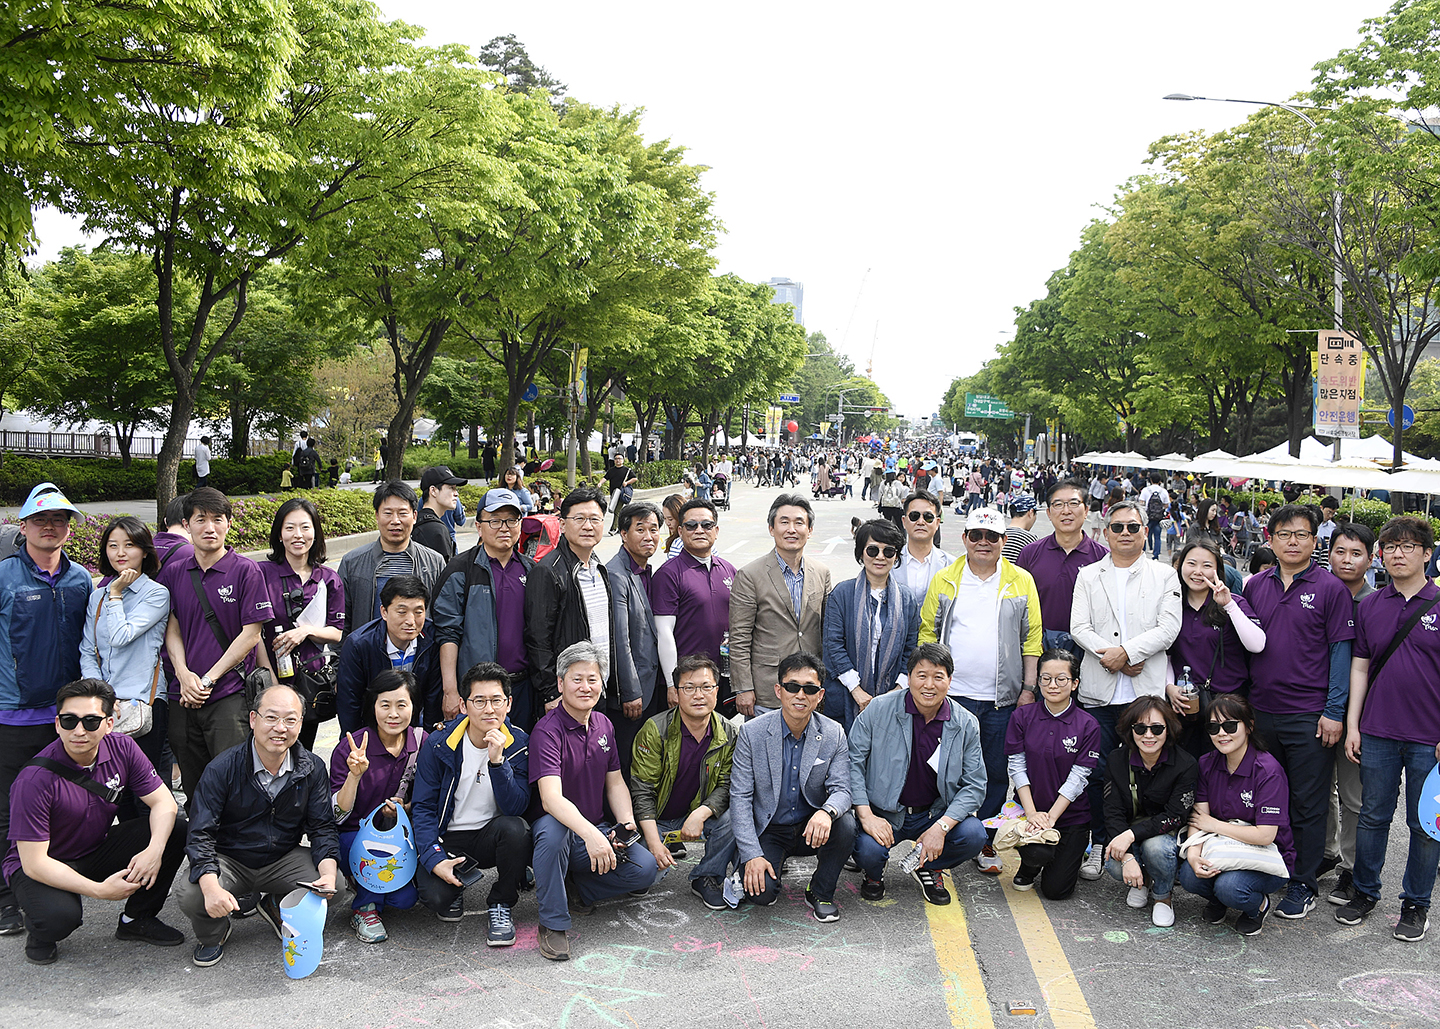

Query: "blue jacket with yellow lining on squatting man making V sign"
left=410, top=715, right=530, bottom=871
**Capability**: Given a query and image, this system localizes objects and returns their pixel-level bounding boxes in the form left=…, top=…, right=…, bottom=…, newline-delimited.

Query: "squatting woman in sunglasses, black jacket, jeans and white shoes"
left=1104, top=697, right=1200, bottom=927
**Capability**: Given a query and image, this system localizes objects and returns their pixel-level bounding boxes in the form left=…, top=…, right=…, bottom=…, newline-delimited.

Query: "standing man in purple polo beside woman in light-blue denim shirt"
left=156, top=486, right=272, bottom=796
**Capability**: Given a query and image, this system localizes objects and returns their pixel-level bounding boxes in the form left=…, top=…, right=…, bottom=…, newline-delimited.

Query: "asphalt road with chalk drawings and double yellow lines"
left=0, top=485, right=1440, bottom=1029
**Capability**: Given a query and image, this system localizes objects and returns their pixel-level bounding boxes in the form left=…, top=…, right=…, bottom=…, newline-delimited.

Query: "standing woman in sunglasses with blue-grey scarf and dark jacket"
left=824, top=518, right=920, bottom=733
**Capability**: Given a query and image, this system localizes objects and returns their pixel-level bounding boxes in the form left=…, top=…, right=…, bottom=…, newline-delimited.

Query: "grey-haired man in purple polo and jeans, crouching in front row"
left=530, top=640, right=658, bottom=961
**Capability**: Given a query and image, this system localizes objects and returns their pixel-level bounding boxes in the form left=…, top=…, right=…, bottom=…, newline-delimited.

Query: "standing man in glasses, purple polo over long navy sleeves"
left=1244, top=504, right=1355, bottom=918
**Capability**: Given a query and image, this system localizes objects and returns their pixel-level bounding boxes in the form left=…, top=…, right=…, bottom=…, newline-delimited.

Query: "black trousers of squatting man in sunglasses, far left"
left=10, top=815, right=187, bottom=943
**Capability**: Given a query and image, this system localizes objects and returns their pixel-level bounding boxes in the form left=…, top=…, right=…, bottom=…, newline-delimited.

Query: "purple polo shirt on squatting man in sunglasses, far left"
left=0, top=733, right=163, bottom=879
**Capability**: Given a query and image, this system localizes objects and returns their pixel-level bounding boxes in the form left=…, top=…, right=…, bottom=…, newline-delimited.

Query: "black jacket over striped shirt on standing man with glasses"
left=526, top=537, right=619, bottom=704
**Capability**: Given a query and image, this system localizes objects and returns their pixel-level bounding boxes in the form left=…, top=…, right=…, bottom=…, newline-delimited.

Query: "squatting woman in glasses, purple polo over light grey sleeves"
left=1005, top=648, right=1100, bottom=901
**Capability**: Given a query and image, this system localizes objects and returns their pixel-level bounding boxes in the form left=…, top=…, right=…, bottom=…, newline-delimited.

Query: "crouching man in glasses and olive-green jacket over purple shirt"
left=631, top=653, right=736, bottom=911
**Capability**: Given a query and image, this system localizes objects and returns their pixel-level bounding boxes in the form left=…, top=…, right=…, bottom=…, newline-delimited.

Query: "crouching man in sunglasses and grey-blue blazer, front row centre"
left=725, top=651, right=855, bottom=923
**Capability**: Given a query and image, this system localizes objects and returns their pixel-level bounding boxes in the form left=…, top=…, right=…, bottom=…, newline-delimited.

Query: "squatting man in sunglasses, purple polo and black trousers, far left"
left=3, top=679, right=186, bottom=964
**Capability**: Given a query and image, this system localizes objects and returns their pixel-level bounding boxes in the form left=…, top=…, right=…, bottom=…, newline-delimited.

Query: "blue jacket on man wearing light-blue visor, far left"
left=0, top=547, right=91, bottom=711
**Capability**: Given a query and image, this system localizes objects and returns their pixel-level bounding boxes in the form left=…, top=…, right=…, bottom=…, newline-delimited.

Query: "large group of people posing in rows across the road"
left=0, top=465, right=1440, bottom=966
